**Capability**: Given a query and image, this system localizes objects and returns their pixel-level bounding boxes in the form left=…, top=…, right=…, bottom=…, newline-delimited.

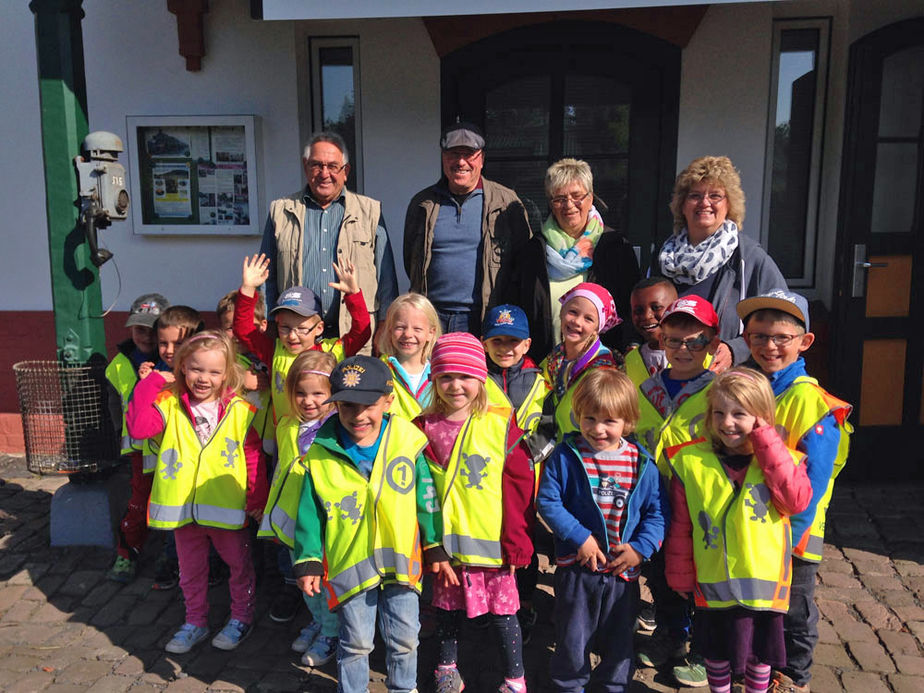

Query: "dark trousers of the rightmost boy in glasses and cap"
left=783, top=556, right=818, bottom=686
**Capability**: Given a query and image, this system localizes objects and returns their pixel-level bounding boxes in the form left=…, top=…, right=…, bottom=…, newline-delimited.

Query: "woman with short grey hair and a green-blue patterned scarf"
left=517, top=159, right=639, bottom=358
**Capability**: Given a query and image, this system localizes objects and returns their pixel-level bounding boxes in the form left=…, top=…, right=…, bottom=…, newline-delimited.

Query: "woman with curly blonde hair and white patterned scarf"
left=658, top=156, right=786, bottom=371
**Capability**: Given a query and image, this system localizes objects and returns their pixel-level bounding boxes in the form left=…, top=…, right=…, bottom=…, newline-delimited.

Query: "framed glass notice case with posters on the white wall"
left=126, top=116, right=262, bottom=236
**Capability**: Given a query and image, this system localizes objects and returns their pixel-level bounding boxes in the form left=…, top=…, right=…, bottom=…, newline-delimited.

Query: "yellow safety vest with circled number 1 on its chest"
left=300, top=416, right=427, bottom=609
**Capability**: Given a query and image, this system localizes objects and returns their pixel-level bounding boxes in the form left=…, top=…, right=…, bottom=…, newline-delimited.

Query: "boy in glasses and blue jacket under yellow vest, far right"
left=737, top=289, right=853, bottom=693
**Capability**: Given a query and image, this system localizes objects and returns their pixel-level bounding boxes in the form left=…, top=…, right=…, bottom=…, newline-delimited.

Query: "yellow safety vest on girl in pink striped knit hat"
left=430, top=407, right=512, bottom=568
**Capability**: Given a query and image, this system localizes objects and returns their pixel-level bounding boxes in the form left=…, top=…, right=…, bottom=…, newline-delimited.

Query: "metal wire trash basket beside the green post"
left=13, top=361, right=121, bottom=474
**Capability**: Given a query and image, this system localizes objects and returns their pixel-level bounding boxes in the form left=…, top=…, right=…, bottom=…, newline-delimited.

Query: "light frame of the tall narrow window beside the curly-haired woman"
left=760, top=17, right=832, bottom=289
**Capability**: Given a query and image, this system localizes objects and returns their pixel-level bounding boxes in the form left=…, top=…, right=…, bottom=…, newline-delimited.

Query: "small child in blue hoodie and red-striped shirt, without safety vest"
left=536, top=368, right=670, bottom=691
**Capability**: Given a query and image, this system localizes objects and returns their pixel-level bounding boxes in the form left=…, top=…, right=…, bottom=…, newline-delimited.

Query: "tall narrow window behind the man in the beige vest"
left=308, top=37, right=363, bottom=193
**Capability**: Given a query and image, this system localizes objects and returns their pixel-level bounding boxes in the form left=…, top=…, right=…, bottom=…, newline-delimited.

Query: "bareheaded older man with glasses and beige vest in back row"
left=260, top=132, right=398, bottom=351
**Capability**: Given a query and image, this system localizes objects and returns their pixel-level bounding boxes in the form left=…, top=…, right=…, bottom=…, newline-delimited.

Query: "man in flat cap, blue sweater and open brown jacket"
left=404, top=123, right=531, bottom=335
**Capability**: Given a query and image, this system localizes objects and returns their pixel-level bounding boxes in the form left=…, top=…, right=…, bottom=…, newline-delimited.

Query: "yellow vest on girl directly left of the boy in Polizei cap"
left=257, top=416, right=305, bottom=549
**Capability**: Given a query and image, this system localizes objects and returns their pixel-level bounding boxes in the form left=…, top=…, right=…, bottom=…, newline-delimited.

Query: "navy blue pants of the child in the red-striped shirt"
left=549, top=565, right=639, bottom=693
